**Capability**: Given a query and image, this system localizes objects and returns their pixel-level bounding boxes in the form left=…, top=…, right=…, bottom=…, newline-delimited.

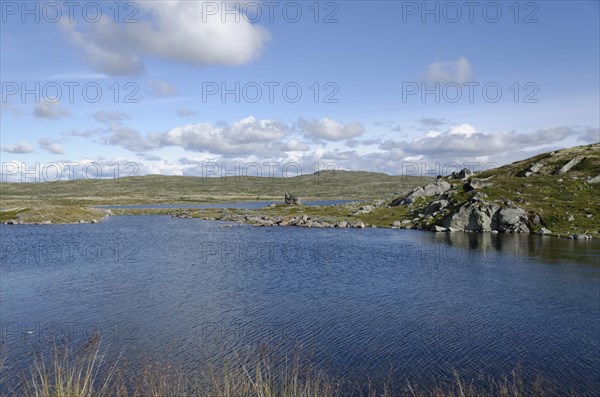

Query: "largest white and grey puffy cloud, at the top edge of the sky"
left=60, top=0, right=270, bottom=75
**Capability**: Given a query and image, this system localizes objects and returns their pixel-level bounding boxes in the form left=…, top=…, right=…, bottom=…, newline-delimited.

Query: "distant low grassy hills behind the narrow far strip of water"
left=0, top=171, right=429, bottom=223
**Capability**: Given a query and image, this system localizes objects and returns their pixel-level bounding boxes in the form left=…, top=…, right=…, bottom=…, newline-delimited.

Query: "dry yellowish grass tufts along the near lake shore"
left=0, top=338, right=575, bottom=397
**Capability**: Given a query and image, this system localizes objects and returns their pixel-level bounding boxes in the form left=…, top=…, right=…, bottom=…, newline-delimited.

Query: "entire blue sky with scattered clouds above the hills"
left=0, top=0, right=600, bottom=182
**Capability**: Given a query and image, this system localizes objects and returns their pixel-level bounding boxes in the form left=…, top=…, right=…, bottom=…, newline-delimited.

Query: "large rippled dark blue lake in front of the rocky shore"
left=0, top=216, right=600, bottom=395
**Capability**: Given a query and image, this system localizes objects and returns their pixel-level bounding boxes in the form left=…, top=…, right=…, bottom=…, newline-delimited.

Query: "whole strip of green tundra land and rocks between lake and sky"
left=0, top=144, right=600, bottom=239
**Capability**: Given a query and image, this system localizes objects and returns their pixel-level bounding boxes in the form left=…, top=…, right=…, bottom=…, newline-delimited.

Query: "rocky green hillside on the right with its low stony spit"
left=134, top=144, right=600, bottom=238
